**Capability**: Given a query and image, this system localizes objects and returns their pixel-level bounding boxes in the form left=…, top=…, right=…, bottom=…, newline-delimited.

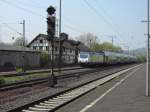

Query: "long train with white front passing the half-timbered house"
left=78, top=51, right=137, bottom=65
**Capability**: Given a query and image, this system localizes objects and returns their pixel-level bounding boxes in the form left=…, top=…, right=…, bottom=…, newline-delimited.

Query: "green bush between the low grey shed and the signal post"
left=40, top=52, right=51, bottom=67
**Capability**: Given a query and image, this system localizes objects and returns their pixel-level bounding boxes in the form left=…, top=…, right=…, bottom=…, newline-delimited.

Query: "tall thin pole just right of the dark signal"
left=59, top=0, right=62, bottom=72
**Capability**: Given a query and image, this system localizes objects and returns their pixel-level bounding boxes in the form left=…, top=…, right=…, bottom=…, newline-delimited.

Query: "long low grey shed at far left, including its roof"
left=0, top=44, right=40, bottom=68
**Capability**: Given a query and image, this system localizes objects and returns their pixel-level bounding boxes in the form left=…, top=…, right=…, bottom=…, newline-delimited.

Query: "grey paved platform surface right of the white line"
left=84, top=65, right=150, bottom=112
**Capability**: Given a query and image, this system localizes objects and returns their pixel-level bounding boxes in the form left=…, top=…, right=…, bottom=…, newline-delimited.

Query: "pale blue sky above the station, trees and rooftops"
left=0, top=0, right=147, bottom=49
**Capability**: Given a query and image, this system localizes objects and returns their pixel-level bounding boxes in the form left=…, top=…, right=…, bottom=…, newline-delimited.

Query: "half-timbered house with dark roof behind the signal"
left=28, top=34, right=89, bottom=64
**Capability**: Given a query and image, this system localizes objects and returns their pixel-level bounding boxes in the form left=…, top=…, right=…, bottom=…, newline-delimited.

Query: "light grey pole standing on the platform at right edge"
left=146, top=0, right=150, bottom=96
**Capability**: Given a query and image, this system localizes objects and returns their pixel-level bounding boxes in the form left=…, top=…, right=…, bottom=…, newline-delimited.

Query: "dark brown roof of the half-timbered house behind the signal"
left=27, top=34, right=92, bottom=52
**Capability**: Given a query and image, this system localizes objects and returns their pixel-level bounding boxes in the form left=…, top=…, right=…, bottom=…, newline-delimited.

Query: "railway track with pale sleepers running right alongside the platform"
left=8, top=65, right=140, bottom=112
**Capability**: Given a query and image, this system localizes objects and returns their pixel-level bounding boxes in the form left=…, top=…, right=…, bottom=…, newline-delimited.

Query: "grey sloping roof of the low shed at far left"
left=0, top=43, right=38, bottom=52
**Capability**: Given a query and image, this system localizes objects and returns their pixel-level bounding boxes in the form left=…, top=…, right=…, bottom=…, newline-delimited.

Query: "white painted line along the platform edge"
left=80, top=67, right=141, bottom=112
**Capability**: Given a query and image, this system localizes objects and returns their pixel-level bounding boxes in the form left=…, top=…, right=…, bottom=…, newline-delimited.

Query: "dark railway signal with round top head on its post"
left=47, top=6, right=57, bottom=87
